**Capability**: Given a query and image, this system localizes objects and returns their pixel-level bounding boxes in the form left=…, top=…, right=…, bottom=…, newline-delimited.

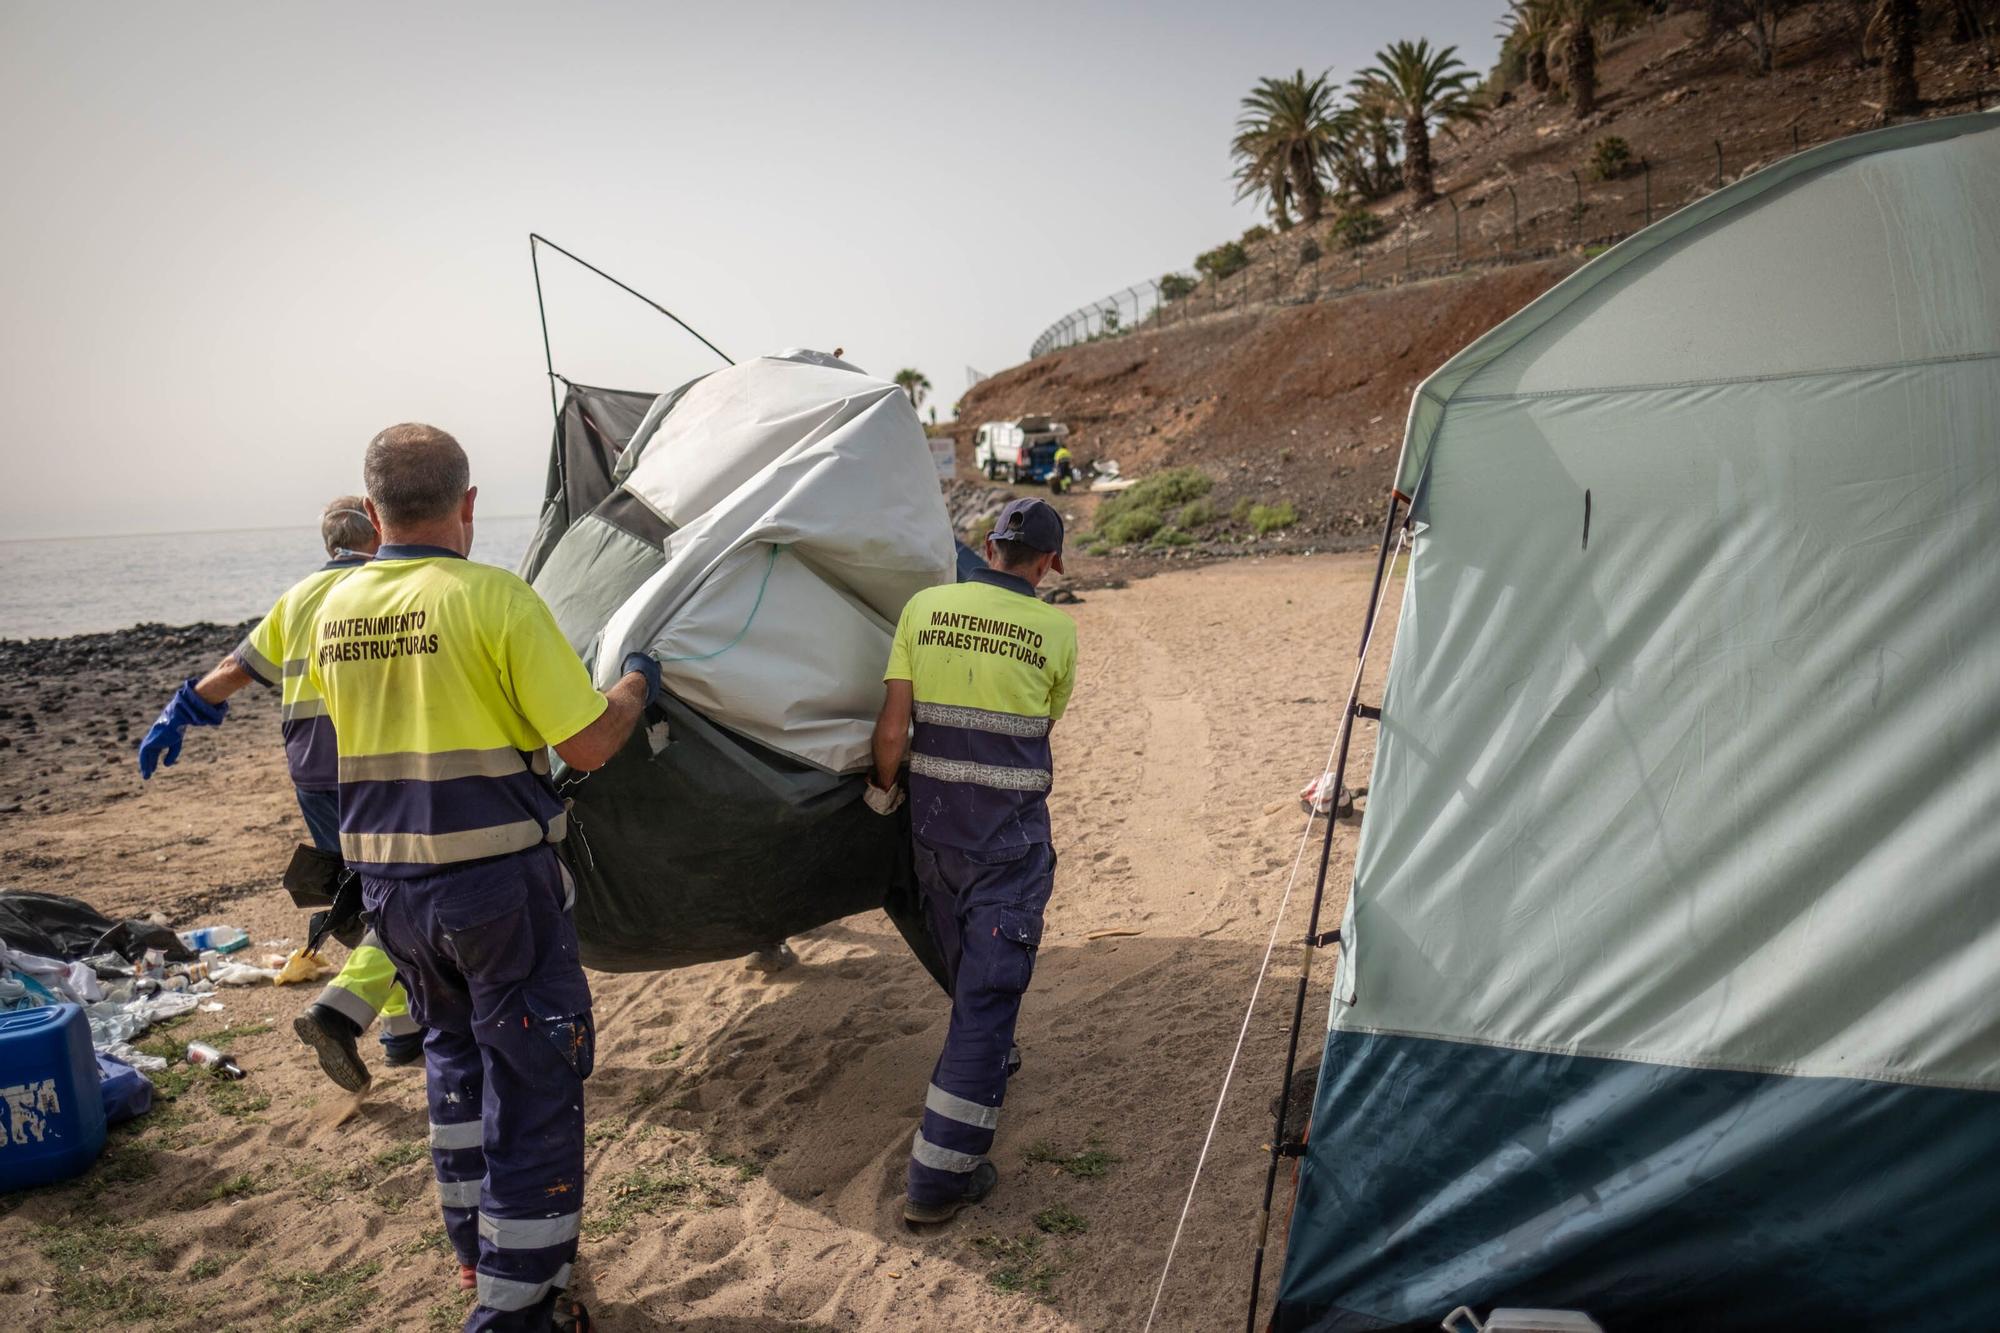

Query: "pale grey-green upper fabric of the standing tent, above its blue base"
left=1336, top=118, right=2000, bottom=1089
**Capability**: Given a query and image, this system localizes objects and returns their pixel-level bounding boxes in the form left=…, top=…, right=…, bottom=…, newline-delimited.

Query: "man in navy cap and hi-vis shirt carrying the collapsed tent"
left=866, top=500, right=1076, bottom=1225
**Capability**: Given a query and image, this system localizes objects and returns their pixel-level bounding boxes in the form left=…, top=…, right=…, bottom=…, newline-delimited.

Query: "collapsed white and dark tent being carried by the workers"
left=522, top=350, right=956, bottom=971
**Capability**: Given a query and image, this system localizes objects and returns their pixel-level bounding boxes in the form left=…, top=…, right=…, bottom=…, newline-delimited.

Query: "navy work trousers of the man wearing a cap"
left=908, top=839, right=1056, bottom=1203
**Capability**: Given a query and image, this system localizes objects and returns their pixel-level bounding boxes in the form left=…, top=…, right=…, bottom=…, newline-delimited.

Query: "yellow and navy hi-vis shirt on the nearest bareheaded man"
left=310, top=546, right=606, bottom=879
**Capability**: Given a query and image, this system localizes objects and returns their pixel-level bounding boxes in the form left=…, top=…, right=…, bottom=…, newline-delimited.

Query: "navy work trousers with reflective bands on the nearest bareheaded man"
left=362, top=847, right=596, bottom=1329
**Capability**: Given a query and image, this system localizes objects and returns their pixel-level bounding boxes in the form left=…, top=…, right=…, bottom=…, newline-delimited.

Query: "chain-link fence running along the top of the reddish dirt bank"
left=1028, top=124, right=1856, bottom=360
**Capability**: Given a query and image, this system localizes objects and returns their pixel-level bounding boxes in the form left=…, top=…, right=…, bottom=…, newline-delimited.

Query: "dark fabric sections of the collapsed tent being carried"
left=522, top=384, right=942, bottom=985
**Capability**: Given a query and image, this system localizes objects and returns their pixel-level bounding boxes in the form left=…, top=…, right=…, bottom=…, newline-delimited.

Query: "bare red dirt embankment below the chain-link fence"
left=958, top=258, right=1580, bottom=550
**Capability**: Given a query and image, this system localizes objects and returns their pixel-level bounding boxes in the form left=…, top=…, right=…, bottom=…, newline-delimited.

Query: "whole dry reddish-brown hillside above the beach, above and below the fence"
left=958, top=2, right=2000, bottom=552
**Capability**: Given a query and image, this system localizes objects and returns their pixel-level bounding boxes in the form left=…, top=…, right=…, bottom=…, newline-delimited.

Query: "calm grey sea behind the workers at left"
left=0, top=516, right=534, bottom=638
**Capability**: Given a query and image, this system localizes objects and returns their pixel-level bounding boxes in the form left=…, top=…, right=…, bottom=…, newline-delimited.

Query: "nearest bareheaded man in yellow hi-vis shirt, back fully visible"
left=310, top=424, right=660, bottom=1329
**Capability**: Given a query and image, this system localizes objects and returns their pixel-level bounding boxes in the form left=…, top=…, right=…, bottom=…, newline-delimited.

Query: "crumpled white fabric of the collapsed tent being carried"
left=592, top=350, right=954, bottom=773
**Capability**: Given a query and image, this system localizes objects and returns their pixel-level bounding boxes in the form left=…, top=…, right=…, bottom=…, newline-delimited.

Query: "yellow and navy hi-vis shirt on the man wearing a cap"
left=882, top=568, right=1076, bottom=851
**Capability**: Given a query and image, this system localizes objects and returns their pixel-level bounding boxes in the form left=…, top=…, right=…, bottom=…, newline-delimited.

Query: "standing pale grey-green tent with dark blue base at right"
left=1276, top=114, right=2000, bottom=1329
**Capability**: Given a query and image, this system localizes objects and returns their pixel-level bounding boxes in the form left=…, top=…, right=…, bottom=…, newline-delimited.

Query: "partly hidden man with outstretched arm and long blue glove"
left=138, top=494, right=424, bottom=1093
